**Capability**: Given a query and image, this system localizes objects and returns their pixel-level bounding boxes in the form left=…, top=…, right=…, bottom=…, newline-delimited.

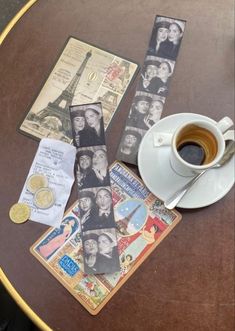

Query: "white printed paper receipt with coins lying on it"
left=19, top=138, right=76, bottom=227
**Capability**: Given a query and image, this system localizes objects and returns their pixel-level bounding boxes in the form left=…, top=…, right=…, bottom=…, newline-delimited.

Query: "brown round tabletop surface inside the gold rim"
left=0, top=0, right=235, bottom=331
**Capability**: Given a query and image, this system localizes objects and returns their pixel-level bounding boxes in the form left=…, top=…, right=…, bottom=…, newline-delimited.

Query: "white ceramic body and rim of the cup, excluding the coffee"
left=154, top=116, right=234, bottom=177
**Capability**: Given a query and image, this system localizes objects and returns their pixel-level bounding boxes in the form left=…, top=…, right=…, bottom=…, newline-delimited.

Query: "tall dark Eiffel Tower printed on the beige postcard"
left=37, top=51, right=92, bottom=138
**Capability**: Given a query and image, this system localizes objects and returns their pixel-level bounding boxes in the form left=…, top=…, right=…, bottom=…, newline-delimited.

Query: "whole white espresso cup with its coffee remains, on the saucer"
left=153, top=116, right=233, bottom=177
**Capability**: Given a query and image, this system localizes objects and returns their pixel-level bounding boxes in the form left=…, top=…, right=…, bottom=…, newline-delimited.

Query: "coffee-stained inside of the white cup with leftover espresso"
left=176, top=124, right=218, bottom=166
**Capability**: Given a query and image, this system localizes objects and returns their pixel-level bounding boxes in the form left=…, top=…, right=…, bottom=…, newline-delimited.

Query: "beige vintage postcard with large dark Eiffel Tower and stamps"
left=19, top=37, right=138, bottom=142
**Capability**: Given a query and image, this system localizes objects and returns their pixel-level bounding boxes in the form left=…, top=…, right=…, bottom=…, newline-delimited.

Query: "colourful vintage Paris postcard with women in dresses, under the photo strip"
left=30, top=162, right=181, bottom=315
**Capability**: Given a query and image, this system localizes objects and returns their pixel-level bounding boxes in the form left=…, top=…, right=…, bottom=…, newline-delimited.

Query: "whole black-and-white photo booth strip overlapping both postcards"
left=70, top=103, right=120, bottom=274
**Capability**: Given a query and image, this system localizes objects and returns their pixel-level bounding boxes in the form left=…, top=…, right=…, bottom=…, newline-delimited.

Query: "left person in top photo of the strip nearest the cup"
left=148, top=21, right=171, bottom=58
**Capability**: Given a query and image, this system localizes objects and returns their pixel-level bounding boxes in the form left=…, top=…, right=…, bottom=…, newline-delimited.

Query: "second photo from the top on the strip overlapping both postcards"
left=76, top=145, right=110, bottom=189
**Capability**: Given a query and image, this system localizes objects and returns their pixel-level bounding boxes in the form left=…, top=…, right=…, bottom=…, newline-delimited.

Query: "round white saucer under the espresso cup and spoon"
left=138, top=113, right=234, bottom=208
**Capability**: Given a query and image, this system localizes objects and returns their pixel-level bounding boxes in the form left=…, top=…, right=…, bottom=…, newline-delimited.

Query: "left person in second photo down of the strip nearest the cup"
left=137, top=60, right=160, bottom=93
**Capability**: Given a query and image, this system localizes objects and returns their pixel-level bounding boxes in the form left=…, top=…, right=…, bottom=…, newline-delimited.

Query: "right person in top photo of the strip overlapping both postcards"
left=85, top=105, right=105, bottom=146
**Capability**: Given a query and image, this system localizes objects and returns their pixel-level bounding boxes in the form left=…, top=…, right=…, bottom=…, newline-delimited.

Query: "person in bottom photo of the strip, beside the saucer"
left=118, top=129, right=141, bottom=162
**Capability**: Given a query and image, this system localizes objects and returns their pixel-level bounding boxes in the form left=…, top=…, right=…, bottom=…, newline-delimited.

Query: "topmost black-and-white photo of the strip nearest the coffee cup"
left=147, top=16, right=185, bottom=61
